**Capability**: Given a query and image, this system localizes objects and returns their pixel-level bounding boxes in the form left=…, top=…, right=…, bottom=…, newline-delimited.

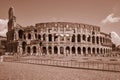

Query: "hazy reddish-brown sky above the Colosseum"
left=0, top=0, right=120, bottom=43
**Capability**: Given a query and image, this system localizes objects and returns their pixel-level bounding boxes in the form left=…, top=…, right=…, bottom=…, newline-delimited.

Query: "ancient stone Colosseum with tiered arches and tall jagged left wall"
left=6, top=7, right=112, bottom=56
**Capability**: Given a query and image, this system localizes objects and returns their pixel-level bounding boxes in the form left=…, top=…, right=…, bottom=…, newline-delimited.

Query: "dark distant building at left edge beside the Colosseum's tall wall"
left=0, top=36, right=7, bottom=55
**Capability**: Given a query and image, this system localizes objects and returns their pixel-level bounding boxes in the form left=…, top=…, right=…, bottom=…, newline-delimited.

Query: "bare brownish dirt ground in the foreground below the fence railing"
left=0, top=62, right=120, bottom=80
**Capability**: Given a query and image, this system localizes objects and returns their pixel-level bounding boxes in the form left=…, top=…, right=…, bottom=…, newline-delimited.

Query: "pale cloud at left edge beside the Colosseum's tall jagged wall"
left=0, top=19, right=8, bottom=36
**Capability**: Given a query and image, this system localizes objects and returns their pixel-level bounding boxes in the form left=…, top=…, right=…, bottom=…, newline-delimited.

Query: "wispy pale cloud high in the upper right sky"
left=102, top=13, right=120, bottom=24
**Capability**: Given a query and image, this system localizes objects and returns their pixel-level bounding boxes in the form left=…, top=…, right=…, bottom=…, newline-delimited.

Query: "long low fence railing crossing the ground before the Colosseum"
left=3, top=57, right=120, bottom=72
